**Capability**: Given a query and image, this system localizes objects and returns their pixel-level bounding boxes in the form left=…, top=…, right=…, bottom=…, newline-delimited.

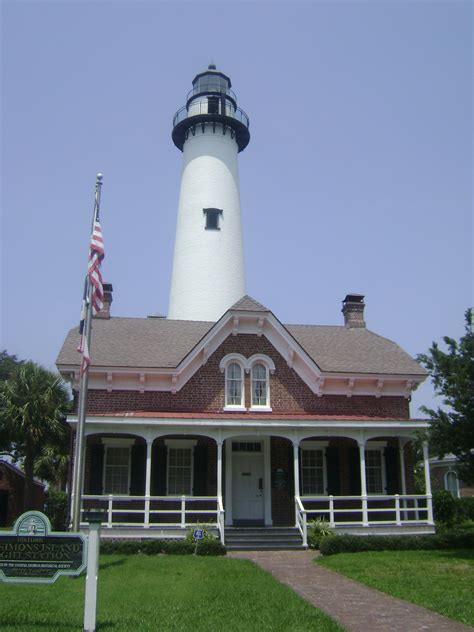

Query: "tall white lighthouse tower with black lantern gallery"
left=168, top=64, right=250, bottom=321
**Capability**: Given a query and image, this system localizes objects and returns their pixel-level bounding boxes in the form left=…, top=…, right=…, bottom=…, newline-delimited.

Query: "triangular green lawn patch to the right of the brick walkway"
left=317, top=550, right=474, bottom=626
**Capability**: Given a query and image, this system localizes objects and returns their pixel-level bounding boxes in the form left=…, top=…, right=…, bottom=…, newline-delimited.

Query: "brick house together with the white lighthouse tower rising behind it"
left=57, top=65, right=433, bottom=547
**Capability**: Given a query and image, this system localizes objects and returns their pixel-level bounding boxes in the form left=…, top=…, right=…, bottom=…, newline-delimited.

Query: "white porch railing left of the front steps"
left=81, top=494, right=224, bottom=544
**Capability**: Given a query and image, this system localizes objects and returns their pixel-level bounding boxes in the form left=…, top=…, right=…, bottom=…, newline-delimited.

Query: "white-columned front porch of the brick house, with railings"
left=72, top=420, right=434, bottom=546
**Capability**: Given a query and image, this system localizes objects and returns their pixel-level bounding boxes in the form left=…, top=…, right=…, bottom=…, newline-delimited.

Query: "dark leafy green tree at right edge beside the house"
left=418, top=309, right=474, bottom=484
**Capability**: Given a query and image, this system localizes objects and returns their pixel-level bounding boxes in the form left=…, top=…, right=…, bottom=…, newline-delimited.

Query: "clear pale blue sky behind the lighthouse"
left=0, top=0, right=474, bottom=416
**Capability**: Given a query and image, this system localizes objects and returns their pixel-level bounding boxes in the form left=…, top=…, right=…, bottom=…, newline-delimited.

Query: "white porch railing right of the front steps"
left=295, top=494, right=434, bottom=530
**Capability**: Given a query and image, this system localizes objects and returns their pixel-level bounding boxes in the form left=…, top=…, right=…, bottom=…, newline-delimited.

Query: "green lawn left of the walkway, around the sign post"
left=0, top=555, right=342, bottom=632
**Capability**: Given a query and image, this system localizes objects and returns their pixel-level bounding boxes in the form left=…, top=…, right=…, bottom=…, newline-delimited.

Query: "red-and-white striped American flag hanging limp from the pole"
left=77, top=217, right=105, bottom=375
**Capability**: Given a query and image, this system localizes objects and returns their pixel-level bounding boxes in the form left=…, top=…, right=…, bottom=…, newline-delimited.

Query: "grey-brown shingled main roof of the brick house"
left=56, top=312, right=425, bottom=376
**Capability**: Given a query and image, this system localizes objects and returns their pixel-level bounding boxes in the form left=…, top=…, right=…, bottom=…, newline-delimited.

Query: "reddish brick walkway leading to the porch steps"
left=228, top=551, right=474, bottom=632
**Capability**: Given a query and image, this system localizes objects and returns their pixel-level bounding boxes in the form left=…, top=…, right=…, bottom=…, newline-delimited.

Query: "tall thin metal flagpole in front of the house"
left=72, top=173, right=102, bottom=531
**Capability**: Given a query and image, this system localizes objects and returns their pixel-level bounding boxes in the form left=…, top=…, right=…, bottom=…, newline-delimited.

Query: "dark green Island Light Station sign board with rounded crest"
left=0, top=511, right=87, bottom=584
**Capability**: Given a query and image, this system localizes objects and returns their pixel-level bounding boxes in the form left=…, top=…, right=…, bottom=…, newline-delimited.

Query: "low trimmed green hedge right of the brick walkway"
left=319, top=529, right=474, bottom=555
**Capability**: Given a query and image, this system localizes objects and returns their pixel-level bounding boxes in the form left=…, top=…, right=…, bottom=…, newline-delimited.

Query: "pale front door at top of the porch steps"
left=232, top=452, right=265, bottom=522
